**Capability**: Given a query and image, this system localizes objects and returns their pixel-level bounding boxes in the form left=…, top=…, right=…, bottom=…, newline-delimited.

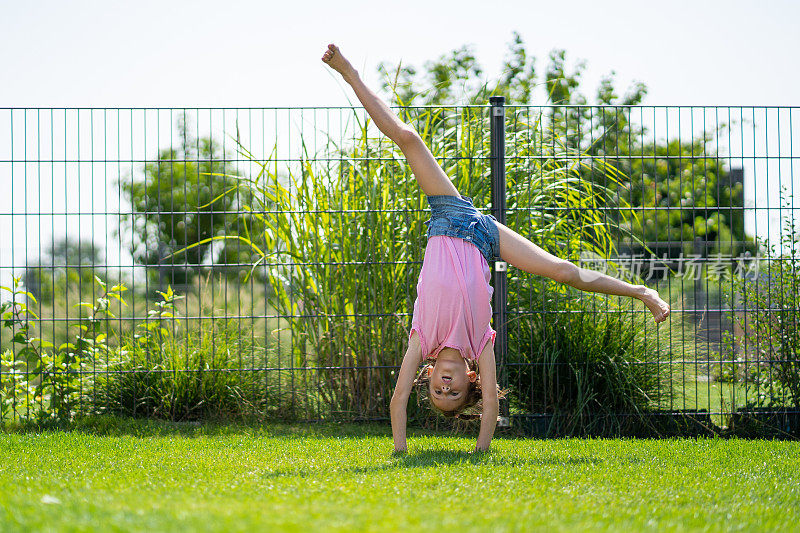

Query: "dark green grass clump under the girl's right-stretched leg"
left=507, top=283, right=680, bottom=436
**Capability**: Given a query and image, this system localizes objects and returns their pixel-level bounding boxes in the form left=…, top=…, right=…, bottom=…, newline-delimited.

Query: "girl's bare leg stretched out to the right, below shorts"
left=497, top=223, right=670, bottom=323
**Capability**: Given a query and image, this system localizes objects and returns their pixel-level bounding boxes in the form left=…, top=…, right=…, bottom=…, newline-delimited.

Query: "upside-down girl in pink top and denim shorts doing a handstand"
left=322, top=44, right=670, bottom=452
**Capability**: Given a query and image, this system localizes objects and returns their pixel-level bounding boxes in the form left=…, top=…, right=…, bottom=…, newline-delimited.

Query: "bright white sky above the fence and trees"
left=0, top=0, right=800, bottom=284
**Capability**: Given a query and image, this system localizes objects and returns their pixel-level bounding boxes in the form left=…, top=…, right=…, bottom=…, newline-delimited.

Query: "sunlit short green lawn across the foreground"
left=0, top=419, right=800, bottom=532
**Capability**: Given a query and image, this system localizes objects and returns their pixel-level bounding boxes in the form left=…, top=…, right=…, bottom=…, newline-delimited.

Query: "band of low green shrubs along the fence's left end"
left=0, top=279, right=294, bottom=423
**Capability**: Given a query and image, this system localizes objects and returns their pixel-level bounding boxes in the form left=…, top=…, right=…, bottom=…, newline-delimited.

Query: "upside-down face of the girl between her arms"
left=428, top=348, right=478, bottom=411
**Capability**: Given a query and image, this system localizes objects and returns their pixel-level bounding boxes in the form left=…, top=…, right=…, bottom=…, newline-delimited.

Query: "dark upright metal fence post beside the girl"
left=489, top=96, right=508, bottom=420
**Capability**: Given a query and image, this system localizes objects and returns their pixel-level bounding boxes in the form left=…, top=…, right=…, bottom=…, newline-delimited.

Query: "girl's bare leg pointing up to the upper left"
left=322, top=44, right=459, bottom=196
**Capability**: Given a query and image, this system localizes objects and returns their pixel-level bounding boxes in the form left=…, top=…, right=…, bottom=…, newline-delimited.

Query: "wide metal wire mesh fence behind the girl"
left=0, top=105, right=800, bottom=435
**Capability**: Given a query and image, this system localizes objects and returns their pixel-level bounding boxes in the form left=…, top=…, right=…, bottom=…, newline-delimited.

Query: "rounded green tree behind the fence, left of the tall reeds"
left=118, top=112, right=252, bottom=286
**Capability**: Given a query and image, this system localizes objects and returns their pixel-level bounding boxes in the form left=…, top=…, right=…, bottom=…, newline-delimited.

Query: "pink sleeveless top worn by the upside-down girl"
left=409, top=235, right=495, bottom=361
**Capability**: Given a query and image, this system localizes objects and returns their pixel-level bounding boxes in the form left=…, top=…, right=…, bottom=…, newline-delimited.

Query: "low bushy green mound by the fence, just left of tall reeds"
left=96, top=288, right=282, bottom=420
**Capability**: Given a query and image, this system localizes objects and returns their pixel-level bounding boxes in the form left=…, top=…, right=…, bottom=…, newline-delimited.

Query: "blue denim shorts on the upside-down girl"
left=425, top=195, right=500, bottom=264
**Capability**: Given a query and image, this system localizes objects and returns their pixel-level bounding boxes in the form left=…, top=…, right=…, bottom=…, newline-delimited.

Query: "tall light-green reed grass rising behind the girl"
left=203, top=107, right=658, bottom=427
